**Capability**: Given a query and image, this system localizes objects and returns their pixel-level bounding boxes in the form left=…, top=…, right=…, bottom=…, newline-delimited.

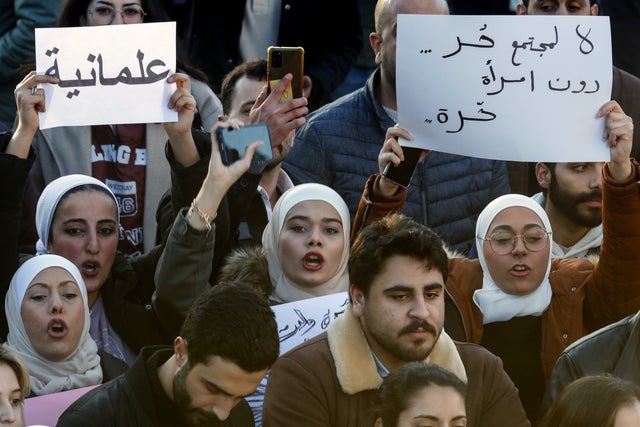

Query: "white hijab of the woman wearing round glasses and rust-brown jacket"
left=473, top=194, right=552, bottom=325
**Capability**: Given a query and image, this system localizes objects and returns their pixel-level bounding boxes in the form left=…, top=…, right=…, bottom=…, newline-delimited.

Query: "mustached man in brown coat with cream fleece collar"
left=263, top=215, right=530, bottom=427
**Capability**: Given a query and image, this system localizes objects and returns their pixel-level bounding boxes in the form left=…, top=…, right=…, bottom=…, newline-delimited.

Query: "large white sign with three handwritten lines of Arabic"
left=396, top=15, right=612, bottom=162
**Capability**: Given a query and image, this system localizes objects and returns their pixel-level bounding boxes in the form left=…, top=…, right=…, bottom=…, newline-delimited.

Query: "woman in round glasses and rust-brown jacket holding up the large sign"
left=353, top=101, right=640, bottom=419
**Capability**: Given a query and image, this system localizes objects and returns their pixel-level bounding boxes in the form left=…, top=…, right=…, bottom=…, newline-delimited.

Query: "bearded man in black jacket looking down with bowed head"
left=57, top=282, right=280, bottom=427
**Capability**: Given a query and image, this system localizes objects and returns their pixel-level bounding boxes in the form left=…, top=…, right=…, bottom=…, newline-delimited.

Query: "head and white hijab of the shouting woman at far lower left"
left=5, top=255, right=102, bottom=395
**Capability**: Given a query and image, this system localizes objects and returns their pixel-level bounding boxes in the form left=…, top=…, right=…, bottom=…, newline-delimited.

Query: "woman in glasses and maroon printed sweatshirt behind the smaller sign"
left=21, top=0, right=222, bottom=256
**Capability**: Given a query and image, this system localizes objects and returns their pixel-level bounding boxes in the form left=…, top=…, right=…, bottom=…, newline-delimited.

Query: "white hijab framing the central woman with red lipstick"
left=262, top=183, right=351, bottom=303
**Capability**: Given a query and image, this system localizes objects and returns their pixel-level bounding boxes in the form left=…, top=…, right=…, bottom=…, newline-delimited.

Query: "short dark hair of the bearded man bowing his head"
left=180, top=282, right=280, bottom=372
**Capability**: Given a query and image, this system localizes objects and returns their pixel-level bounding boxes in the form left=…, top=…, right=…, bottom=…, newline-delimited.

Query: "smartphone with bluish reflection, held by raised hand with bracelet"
left=216, top=123, right=273, bottom=174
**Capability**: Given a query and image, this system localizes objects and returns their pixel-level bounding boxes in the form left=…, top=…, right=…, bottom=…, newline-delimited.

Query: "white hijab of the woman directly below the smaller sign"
left=36, top=174, right=120, bottom=255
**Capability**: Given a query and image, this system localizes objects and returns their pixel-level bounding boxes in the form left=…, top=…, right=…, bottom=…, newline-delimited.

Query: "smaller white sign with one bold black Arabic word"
left=35, top=22, right=178, bottom=129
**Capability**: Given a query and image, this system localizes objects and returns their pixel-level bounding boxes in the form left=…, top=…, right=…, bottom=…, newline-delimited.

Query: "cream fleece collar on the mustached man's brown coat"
left=327, top=306, right=467, bottom=394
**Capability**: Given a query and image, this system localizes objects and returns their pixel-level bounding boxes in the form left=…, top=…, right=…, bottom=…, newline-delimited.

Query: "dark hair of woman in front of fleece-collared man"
left=374, top=362, right=467, bottom=427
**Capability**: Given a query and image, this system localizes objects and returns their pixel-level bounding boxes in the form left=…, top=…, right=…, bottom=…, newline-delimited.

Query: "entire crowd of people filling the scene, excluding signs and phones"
left=0, top=0, right=640, bottom=427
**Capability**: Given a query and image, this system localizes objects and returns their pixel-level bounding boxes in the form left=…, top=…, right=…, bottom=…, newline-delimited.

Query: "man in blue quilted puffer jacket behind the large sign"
left=284, top=0, right=509, bottom=253
